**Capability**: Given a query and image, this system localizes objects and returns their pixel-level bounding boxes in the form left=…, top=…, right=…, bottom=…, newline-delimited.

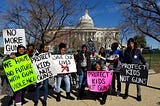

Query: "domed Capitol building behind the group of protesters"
left=48, top=10, right=120, bottom=50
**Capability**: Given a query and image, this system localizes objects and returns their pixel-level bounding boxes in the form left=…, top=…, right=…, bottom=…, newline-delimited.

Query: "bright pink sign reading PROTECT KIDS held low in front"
left=87, top=71, right=112, bottom=92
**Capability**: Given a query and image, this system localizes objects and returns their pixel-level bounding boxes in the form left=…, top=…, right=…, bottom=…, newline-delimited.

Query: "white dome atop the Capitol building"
left=77, top=9, right=94, bottom=28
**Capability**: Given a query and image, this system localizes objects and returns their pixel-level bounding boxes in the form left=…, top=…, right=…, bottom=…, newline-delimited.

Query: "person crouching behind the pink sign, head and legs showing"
left=92, top=62, right=108, bottom=105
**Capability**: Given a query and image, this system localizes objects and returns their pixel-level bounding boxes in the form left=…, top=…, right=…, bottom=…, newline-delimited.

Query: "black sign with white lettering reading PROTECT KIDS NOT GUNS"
left=120, top=64, right=148, bottom=85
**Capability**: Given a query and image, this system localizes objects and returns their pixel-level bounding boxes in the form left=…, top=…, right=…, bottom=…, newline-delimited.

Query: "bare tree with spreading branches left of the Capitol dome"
left=1, top=0, right=97, bottom=43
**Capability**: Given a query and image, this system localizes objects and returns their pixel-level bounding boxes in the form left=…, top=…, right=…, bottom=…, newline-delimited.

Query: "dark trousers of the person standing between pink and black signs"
left=112, top=72, right=121, bottom=92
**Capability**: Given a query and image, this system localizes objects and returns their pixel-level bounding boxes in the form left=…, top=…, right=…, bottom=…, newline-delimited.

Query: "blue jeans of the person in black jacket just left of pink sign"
left=79, top=69, right=87, bottom=89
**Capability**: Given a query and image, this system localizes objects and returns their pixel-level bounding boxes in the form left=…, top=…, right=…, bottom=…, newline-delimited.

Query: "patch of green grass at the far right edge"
left=143, top=53, right=160, bottom=73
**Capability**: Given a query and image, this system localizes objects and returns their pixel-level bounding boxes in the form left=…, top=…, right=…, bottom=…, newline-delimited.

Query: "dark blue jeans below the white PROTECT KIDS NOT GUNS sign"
left=35, top=79, right=48, bottom=101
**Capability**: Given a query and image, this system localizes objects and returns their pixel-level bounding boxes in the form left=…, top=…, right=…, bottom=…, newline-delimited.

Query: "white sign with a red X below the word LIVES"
left=52, top=54, right=77, bottom=74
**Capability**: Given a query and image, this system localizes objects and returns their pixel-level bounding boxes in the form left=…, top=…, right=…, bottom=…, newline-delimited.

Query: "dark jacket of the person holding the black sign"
left=124, top=48, right=146, bottom=64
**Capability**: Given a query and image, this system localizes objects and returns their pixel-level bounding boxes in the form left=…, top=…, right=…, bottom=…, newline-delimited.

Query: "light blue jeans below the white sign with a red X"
left=56, top=75, right=71, bottom=93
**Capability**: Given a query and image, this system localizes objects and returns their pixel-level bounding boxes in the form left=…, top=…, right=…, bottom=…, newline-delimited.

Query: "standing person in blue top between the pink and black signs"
left=109, top=42, right=123, bottom=96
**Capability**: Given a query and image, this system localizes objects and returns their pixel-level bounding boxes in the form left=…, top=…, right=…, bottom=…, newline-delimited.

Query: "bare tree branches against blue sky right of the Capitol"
left=118, top=0, right=160, bottom=42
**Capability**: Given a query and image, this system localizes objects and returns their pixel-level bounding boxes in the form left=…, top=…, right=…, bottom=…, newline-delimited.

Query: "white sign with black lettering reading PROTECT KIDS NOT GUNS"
left=31, top=52, right=56, bottom=83
